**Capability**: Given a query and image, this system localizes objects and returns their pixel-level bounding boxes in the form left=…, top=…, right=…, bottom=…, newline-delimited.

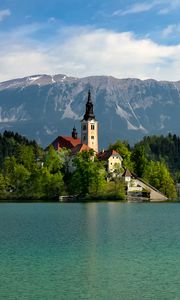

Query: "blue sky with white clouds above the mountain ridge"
left=0, top=0, right=180, bottom=81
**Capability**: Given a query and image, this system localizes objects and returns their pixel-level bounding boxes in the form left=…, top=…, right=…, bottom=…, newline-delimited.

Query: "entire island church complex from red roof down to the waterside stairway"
left=48, top=90, right=167, bottom=201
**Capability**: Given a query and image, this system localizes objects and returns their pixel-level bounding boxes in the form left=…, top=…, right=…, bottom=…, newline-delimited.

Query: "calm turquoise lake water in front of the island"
left=0, top=203, right=180, bottom=300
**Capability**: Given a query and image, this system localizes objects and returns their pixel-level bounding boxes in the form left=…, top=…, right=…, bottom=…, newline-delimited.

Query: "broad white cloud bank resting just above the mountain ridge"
left=0, top=25, right=180, bottom=81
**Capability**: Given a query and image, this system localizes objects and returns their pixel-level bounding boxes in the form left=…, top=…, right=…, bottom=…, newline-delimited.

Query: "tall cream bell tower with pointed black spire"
left=81, top=91, right=98, bottom=153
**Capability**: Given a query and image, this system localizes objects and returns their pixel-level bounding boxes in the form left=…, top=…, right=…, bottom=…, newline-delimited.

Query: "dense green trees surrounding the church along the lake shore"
left=0, top=131, right=180, bottom=201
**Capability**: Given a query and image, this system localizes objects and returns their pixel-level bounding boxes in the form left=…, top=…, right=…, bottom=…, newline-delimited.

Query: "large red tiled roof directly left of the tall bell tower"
left=51, top=136, right=81, bottom=150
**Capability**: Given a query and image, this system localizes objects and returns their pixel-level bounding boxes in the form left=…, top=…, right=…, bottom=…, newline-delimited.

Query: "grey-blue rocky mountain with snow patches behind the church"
left=0, top=75, right=180, bottom=147
